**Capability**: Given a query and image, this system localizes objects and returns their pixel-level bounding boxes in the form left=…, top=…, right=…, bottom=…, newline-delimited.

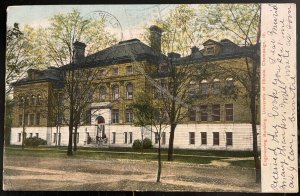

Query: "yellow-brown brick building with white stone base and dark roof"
left=11, top=26, right=259, bottom=150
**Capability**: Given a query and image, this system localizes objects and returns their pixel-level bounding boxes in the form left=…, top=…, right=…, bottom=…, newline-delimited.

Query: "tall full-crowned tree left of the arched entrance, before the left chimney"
left=28, top=10, right=116, bottom=155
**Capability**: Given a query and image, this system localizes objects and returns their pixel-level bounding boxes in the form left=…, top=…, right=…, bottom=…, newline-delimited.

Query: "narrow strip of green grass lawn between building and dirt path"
left=4, top=146, right=254, bottom=167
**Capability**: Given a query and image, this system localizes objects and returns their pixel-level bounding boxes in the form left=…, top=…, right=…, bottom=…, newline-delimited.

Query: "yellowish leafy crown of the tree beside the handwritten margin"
left=197, top=3, right=260, bottom=45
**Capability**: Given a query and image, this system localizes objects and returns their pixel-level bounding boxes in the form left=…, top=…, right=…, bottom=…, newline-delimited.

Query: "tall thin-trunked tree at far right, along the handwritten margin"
left=199, top=4, right=260, bottom=182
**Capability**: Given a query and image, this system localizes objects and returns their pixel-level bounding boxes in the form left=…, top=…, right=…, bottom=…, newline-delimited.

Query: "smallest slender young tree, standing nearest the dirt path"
left=131, top=91, right=168, bottom=182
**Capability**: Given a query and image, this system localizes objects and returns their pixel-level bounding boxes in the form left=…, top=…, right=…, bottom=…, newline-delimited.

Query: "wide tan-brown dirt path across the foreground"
left=4, top=157, right=259, bottom=192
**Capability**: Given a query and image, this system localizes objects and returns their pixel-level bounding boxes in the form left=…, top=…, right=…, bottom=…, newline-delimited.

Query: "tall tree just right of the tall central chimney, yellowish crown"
left=145, top=5, right=210, bottom=161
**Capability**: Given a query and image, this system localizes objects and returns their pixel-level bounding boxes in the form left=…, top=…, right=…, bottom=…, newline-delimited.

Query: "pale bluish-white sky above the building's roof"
left=7, top=4, right=177, bottom=40
